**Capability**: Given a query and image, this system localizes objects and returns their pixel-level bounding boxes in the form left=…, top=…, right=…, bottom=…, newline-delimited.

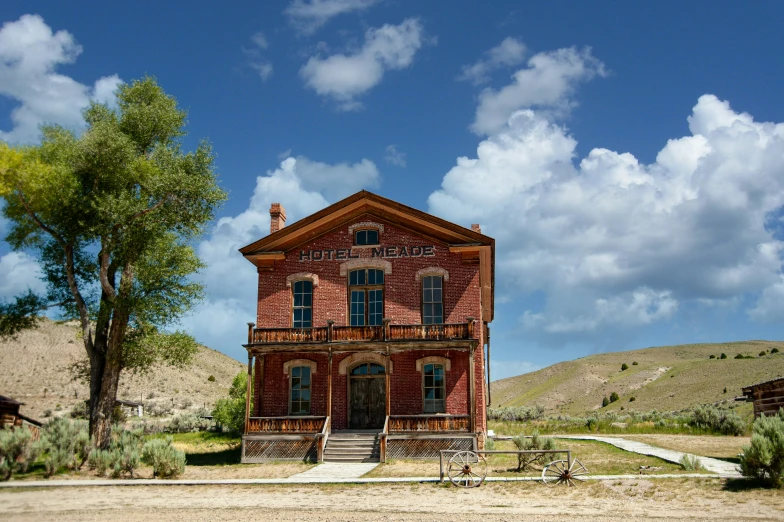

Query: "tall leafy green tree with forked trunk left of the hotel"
left=0, top=77, right=226, bottom=448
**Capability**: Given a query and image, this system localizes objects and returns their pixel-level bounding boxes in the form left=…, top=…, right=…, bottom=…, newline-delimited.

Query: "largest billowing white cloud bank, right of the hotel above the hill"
left=428, top=95, right=784, bottom=338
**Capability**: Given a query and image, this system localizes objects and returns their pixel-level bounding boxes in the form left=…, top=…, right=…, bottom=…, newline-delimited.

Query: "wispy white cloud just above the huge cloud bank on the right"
left=471, top=47, right=606, bottom=135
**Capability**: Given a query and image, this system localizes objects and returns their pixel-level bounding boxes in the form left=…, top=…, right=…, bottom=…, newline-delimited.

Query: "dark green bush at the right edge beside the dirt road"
left=740, top=410, right=784, bottom=488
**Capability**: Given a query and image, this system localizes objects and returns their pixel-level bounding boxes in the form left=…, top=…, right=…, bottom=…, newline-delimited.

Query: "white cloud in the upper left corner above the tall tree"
left=0, top=15, right=120, bottom=143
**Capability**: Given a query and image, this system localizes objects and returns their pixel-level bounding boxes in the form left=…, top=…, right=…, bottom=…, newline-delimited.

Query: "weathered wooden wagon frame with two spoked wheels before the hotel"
left=439, top=444, right=588, bottom=488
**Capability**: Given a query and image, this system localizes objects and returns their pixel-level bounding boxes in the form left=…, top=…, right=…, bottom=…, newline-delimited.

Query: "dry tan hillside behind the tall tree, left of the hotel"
left=0, top=319, right=245, bottom=420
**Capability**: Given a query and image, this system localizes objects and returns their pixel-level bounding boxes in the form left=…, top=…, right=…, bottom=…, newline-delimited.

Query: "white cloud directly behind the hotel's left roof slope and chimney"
left=182, top=156, right=380, bottom=358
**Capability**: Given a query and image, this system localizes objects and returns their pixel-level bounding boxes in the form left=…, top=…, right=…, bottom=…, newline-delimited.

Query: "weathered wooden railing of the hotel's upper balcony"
left=248, top=317, right=474, bottom=344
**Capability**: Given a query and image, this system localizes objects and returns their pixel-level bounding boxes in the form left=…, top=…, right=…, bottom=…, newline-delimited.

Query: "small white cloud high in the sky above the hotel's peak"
left=300, top=18, right=424, bottom=111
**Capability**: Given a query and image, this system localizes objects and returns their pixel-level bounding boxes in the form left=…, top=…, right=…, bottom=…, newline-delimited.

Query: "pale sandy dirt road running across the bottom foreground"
left=0, top=479, right=784, bottom=522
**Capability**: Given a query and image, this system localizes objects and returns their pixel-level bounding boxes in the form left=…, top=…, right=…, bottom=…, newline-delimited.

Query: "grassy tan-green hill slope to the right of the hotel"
left=490, top=341, right=784, bottom=415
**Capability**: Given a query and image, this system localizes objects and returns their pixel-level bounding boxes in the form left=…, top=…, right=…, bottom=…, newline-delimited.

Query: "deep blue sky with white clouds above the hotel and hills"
left=0, top=0, right=784, bottom=378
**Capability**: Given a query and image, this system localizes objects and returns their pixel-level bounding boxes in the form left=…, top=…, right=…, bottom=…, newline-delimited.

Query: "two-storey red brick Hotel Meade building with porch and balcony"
left=240, top=191, right=495, bottom=462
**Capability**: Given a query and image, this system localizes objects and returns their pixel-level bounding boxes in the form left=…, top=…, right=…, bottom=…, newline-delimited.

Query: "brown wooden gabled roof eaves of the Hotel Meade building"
left=240, top=190, right=495, bottom=322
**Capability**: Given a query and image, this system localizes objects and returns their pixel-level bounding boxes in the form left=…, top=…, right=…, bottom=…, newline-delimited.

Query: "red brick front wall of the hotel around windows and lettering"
left=254, top=216, right=486, bottom=431
